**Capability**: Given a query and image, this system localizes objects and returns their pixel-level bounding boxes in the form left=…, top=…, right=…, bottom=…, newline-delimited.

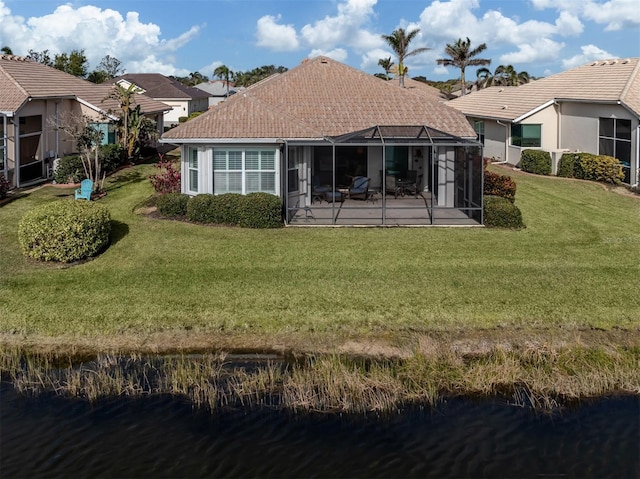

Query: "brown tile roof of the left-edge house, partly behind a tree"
left=0, top=55, right=170, bottom=117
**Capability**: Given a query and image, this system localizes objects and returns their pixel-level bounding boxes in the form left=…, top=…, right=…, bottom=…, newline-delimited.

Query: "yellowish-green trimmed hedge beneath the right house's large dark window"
left=558, top=153, right=624, bottom=184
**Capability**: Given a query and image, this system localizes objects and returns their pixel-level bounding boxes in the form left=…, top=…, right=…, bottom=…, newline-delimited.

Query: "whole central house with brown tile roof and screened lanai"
left=161, top=57, right=483, bottom=226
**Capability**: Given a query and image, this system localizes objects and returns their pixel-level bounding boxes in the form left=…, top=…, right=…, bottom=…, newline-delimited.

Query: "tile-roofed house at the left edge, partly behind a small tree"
left=0, top=55, right=169, bottom=187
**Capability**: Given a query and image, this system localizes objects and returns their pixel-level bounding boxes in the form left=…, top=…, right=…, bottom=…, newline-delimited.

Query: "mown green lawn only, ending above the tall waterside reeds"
left=0, top=165, right=640, bottom=348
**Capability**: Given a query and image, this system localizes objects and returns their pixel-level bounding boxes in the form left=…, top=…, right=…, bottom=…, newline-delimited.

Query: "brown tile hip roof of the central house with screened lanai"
left=163, top=57, right=476, bottom=140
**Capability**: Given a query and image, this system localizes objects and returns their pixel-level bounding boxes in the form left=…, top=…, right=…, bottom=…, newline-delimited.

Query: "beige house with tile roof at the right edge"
left=448, top=58, right=640, bottom=184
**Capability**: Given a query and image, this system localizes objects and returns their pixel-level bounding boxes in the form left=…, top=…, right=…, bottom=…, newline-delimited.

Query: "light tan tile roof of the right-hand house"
left=448, top=58, right=640, bottom=120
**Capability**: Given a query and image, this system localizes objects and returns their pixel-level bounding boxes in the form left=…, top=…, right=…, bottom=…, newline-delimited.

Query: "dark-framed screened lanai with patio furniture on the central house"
left=283, top=126, right=483, bottom=226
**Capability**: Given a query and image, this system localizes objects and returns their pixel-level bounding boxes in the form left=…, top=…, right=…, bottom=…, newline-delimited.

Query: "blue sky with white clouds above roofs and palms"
left=0, top=0, right=640, bottom=80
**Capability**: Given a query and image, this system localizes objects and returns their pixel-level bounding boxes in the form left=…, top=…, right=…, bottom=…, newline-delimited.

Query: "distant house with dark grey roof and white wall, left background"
left=110, top=73, right=210, bottom=127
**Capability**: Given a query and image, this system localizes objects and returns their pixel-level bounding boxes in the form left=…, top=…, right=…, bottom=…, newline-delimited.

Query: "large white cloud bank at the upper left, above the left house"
left=0, top=0, right=201, bottom=75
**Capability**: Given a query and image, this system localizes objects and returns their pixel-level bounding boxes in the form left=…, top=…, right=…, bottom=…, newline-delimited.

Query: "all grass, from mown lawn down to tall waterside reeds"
left=0, top=165, right=640, bottom=410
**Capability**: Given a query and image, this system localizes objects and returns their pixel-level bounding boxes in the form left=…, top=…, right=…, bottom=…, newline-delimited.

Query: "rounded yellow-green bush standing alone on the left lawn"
left=18, top=200, right=111, bottom=263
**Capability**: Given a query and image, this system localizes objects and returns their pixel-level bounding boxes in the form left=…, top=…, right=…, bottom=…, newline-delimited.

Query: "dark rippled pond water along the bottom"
left=0, top=383, right=640, bottom=478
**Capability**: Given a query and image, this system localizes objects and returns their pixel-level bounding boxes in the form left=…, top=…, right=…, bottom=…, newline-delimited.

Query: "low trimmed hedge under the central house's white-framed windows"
left=156, top=193, right=283, bottom=228
